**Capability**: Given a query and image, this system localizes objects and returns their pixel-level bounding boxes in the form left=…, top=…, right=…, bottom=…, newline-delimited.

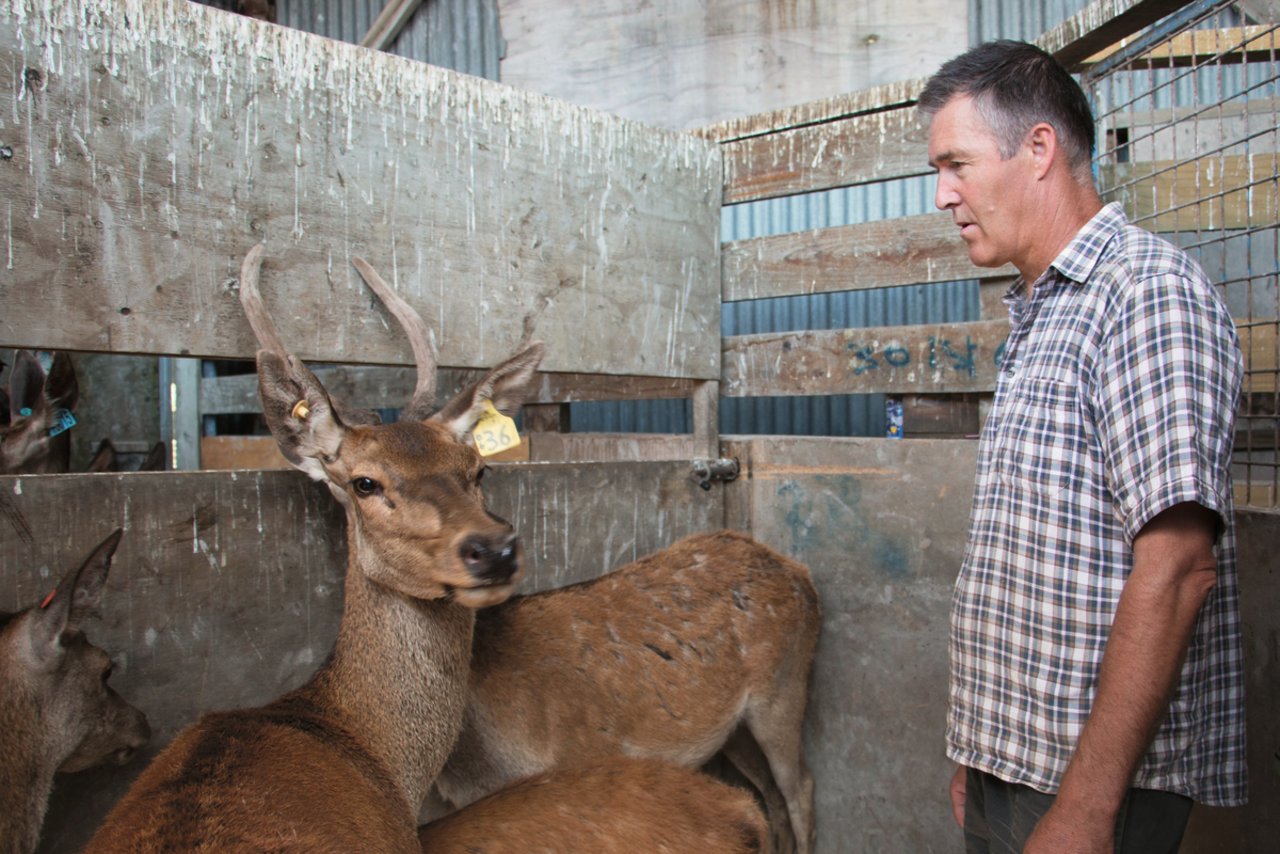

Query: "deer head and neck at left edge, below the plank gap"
left=0, top=529, right=151, bottom=854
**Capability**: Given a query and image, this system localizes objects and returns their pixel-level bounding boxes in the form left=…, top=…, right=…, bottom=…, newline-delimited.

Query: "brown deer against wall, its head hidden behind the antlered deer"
left=435, top=530, right=822, bottom=854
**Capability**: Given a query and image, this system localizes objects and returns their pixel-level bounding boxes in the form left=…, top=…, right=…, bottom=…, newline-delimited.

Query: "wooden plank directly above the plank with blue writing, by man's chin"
left=721, top=214, right=1016, bottom=302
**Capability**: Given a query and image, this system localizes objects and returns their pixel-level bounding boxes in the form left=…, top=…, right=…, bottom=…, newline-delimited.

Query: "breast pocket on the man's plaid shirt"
left=992, top=375, right=1088, bottom=498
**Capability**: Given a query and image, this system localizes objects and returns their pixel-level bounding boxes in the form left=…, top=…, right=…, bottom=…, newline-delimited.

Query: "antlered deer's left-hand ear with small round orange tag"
left=257, top=350, right=347, bottom=480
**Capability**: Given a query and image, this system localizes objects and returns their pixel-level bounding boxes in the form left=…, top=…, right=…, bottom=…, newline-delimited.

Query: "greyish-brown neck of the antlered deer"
left=296, top=536, right=475, bottom=814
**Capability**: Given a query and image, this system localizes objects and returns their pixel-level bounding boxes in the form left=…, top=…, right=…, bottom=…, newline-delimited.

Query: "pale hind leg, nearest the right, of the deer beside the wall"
left=745, top=696, right=815, bottom=854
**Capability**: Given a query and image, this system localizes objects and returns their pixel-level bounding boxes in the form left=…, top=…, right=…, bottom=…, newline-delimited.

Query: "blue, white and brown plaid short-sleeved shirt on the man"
left=947, top=205, right=1245, bottom=805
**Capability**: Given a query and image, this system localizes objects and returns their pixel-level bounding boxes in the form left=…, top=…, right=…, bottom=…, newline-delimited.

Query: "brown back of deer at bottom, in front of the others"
left=417, top=755, right=769, bottom=854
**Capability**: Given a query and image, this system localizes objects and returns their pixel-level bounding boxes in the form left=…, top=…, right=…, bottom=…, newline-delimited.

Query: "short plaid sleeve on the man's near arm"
left=1093, top=267, right=1243, bottom=545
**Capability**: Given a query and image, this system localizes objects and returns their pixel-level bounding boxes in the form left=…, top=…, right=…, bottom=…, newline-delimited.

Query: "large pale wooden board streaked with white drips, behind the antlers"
left=0, top=0, right=721, bottom=380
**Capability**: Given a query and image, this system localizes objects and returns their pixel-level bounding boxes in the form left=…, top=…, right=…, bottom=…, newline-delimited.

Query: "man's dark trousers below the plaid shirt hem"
left=964, top=768, right=1192, bottom=854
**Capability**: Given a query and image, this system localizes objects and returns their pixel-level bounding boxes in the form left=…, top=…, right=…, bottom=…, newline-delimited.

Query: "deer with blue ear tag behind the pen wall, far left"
left=0, top=350, right=79, bottom=475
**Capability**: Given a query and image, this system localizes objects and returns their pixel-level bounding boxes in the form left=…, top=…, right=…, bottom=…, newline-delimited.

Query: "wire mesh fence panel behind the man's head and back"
left=1082, top=1, right=1280, bottom=507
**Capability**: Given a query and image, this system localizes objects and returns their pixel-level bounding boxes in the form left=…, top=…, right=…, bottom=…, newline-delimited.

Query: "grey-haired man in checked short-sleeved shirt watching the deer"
left=919, top=41, right=1245, bottom=854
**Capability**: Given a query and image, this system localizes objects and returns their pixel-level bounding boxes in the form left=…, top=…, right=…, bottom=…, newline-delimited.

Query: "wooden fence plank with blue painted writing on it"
left=721, top=320, right=1009, bottom=397
